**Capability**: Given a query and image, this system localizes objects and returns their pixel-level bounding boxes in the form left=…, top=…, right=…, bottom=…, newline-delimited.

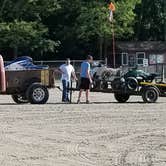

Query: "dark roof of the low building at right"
left=116, top=41, right=166, bottom=51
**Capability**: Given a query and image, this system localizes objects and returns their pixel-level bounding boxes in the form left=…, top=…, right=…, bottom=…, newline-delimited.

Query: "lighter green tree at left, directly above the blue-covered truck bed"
left=0, top=21, right=58, bottom=57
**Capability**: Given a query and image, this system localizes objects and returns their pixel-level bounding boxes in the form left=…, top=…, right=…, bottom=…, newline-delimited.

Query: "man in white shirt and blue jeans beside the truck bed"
left=59, top=59, right=77, bottom=102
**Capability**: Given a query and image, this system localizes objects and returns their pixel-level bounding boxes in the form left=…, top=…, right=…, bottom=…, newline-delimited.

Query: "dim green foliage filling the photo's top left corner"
left=0, top=0, right=59, bottom=21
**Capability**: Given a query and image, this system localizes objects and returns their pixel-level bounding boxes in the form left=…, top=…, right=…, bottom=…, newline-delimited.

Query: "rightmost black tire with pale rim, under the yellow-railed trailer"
left=142, top=87, right=159, bottom=103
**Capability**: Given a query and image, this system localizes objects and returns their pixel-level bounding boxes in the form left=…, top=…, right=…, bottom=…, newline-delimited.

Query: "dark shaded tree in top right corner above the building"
left=135, top=0, right=166, bottom=40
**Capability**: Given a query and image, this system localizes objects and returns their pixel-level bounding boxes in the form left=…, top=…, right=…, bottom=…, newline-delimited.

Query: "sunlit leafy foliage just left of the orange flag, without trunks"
left=75, top=1, right=111, bottom=41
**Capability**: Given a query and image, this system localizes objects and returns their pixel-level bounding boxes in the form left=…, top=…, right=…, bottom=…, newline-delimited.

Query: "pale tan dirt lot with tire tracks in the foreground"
left=0, top=90, right=166, bottom=166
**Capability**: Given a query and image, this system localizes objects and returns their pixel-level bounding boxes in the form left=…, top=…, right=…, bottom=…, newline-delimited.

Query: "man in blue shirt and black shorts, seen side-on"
left=77, top=55, right=93, bottom=104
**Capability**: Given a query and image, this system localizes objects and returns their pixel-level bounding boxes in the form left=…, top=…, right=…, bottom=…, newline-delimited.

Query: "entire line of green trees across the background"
left=0, top=0, right=166, bottom=60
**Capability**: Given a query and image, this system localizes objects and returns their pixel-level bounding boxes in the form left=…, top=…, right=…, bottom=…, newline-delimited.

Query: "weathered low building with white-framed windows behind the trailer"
left=109, top=41, right=166, bottom=76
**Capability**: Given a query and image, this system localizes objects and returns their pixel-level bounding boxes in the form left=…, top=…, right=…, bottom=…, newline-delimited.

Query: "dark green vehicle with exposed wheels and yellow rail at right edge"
left=111, top=70, right=166, bottom=103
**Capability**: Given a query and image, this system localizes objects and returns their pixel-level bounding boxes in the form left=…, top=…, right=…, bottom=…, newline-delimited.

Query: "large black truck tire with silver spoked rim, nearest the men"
left=26, top=83, right=49, bottom=104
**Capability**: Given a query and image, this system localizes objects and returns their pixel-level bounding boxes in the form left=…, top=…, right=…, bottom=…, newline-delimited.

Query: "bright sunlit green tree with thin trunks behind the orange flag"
left=75, top=0, right=139, bottom=58
